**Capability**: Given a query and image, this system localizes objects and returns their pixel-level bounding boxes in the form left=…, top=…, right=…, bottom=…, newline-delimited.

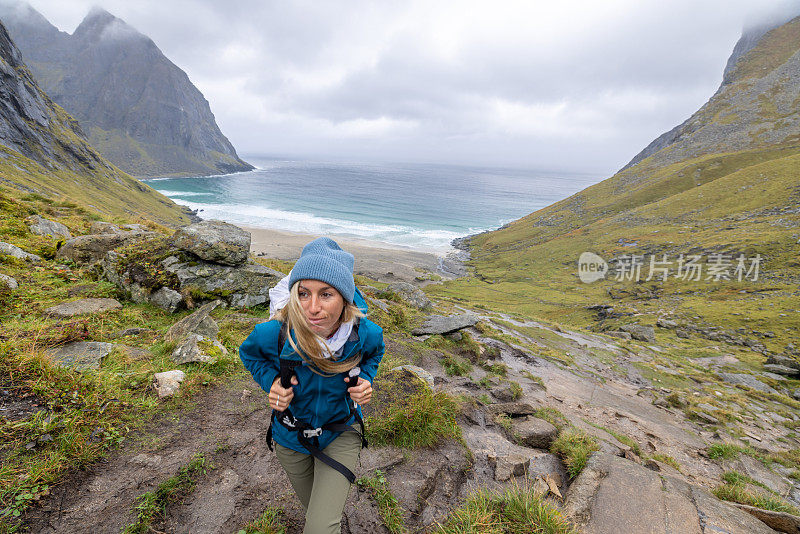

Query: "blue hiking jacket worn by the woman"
left=239, top=300, right=385, bottom=454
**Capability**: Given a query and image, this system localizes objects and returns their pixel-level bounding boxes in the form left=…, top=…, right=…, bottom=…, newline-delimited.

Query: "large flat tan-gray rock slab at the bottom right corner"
left=563, top=452, right=773, bottom=534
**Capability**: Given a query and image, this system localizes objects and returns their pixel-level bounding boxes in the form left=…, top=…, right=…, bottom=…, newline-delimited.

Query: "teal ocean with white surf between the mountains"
left=146, top=157, right=603, bottom=252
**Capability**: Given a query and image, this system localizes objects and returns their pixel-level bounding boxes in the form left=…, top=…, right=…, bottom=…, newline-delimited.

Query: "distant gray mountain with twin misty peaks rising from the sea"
left=0, top=3, right=253, bottom=176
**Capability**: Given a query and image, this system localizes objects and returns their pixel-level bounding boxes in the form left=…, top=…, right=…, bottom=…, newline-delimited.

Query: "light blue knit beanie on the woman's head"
left=289, top=237, right=356, bottom=302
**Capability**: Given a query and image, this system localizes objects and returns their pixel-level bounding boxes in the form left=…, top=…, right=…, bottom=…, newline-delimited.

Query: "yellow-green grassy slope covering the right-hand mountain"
left=427, top=31, right=800, bottom=351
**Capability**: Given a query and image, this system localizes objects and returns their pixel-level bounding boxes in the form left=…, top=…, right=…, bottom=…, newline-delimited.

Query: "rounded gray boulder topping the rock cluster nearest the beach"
left=172, top=220, right=250, bottom=265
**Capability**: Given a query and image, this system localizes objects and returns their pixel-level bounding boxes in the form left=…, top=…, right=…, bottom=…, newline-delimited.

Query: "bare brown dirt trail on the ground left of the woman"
left=26, top=378, right=310, bottom=534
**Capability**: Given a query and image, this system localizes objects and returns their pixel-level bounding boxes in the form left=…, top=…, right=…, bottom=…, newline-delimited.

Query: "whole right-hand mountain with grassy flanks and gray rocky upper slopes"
left=436, top=17, right=800, bottom=365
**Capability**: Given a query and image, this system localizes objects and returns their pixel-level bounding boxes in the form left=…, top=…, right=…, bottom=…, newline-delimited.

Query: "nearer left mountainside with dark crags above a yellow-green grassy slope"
left=0, top=17, right=190, bottom=224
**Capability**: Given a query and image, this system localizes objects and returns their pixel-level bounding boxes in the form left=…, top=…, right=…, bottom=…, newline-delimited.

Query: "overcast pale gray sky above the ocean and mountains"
left=15, top=0, right=800, bottom=176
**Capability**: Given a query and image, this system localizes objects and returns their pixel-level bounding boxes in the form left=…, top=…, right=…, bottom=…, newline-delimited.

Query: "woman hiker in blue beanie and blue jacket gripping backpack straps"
left=239, top=237, right=384, bottom=534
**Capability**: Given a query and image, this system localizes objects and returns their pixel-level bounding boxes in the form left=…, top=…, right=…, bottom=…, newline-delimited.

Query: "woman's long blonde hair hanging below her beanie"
left=271, top=283, right=364, bottom=376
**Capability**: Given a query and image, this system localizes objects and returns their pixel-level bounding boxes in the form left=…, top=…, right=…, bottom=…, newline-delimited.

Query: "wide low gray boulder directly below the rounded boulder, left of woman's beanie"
left=166, top=261, right=286, bottom=308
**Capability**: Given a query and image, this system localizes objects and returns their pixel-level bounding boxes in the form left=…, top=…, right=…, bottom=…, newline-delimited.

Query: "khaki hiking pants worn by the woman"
left=275, top=432, right=361, bottom=534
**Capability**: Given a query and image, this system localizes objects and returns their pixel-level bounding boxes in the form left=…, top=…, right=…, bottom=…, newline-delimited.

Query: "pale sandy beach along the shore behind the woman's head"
left=242, top=226, right=456, bottom=283
